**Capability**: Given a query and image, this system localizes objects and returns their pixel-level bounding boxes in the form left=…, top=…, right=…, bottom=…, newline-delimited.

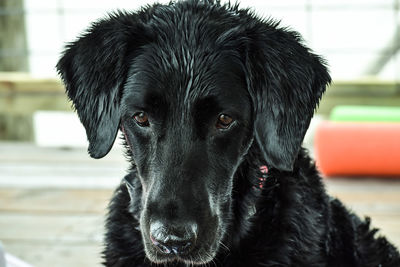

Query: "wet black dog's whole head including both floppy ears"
left=57, top=1, right=330, bottom=264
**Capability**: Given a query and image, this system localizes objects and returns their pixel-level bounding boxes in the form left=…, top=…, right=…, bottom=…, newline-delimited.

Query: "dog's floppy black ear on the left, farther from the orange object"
left=56, top=13, right=148, bottom=158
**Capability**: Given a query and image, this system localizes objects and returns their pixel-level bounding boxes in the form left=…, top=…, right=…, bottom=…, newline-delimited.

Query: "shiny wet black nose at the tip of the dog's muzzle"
left=150, top=221, right=197, bottom=255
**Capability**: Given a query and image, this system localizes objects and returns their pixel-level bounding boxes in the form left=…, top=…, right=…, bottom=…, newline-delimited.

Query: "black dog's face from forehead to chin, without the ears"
left=121, top=47, right=253, bottom=263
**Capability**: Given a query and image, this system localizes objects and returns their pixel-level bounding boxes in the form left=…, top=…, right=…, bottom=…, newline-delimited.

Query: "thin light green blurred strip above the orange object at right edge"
left=330, top=103, right=400, bottom=122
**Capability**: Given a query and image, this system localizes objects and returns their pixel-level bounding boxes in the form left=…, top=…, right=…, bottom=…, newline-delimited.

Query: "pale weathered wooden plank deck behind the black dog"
left=0, top=143, right=400, bottom=267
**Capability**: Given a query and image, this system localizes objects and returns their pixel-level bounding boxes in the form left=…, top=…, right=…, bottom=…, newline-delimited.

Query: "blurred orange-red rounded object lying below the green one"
left=315, top=122, right=400, bottom=178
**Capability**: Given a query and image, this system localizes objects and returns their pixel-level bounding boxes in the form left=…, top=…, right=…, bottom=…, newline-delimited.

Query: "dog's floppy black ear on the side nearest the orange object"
left=246, top=24, right=331, bottom=171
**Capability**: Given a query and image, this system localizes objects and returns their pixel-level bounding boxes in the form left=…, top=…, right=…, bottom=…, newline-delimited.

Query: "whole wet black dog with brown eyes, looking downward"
left=57, top=0, right=400, bottom=267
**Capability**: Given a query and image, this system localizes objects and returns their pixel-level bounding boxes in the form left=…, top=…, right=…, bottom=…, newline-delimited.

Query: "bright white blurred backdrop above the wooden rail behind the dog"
left=21, top=0, right=400, bottom=80
